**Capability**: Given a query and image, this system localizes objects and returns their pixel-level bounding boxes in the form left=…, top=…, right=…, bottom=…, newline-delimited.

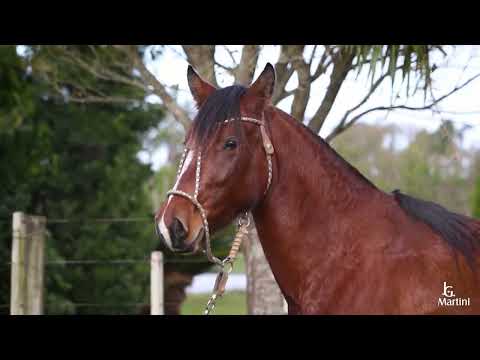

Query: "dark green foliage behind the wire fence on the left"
left=0, top=46, right=163, bottom=314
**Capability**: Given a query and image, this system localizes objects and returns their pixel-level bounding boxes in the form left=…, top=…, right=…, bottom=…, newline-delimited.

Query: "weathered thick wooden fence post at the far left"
left=10, top=212, right=46, bottom=315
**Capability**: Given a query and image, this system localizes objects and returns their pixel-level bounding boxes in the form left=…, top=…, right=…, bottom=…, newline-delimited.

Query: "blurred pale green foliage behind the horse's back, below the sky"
left=333, top=122, right=480, bottom=215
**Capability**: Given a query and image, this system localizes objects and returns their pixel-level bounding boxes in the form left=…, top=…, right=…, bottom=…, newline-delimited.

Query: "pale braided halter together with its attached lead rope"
left=163, top=117, right=274, bottom=315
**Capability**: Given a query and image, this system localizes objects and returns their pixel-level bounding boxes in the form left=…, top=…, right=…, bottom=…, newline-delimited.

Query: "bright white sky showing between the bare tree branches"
left=140, top=45, right=480, bottom=169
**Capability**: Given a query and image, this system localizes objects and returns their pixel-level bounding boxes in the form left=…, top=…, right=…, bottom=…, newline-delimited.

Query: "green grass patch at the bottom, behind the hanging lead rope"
left=181, top=291, right=247, bottom=315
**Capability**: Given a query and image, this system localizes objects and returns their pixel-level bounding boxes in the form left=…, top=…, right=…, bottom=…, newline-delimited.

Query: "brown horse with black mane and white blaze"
left=155, top=64, right=480, bottom=314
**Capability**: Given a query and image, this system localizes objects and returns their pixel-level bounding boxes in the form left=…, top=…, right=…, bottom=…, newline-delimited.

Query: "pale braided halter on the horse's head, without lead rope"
left=167, top=116, right=274, bottom=266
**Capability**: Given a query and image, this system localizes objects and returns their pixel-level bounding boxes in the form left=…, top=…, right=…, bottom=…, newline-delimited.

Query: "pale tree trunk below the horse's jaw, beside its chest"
left=243, top=215, right=287, bottom=315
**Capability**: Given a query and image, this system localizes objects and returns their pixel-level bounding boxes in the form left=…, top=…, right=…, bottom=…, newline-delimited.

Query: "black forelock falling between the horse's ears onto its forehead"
left=192, top=85, right=247, bottom=144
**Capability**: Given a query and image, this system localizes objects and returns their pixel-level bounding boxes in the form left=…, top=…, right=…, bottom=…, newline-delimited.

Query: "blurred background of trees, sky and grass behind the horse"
left=0, top=45, right=480, bottom=315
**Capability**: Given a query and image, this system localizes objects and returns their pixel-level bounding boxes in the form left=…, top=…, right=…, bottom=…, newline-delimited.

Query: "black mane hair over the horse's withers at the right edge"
left=393, top=190, right=480, bottom=265
